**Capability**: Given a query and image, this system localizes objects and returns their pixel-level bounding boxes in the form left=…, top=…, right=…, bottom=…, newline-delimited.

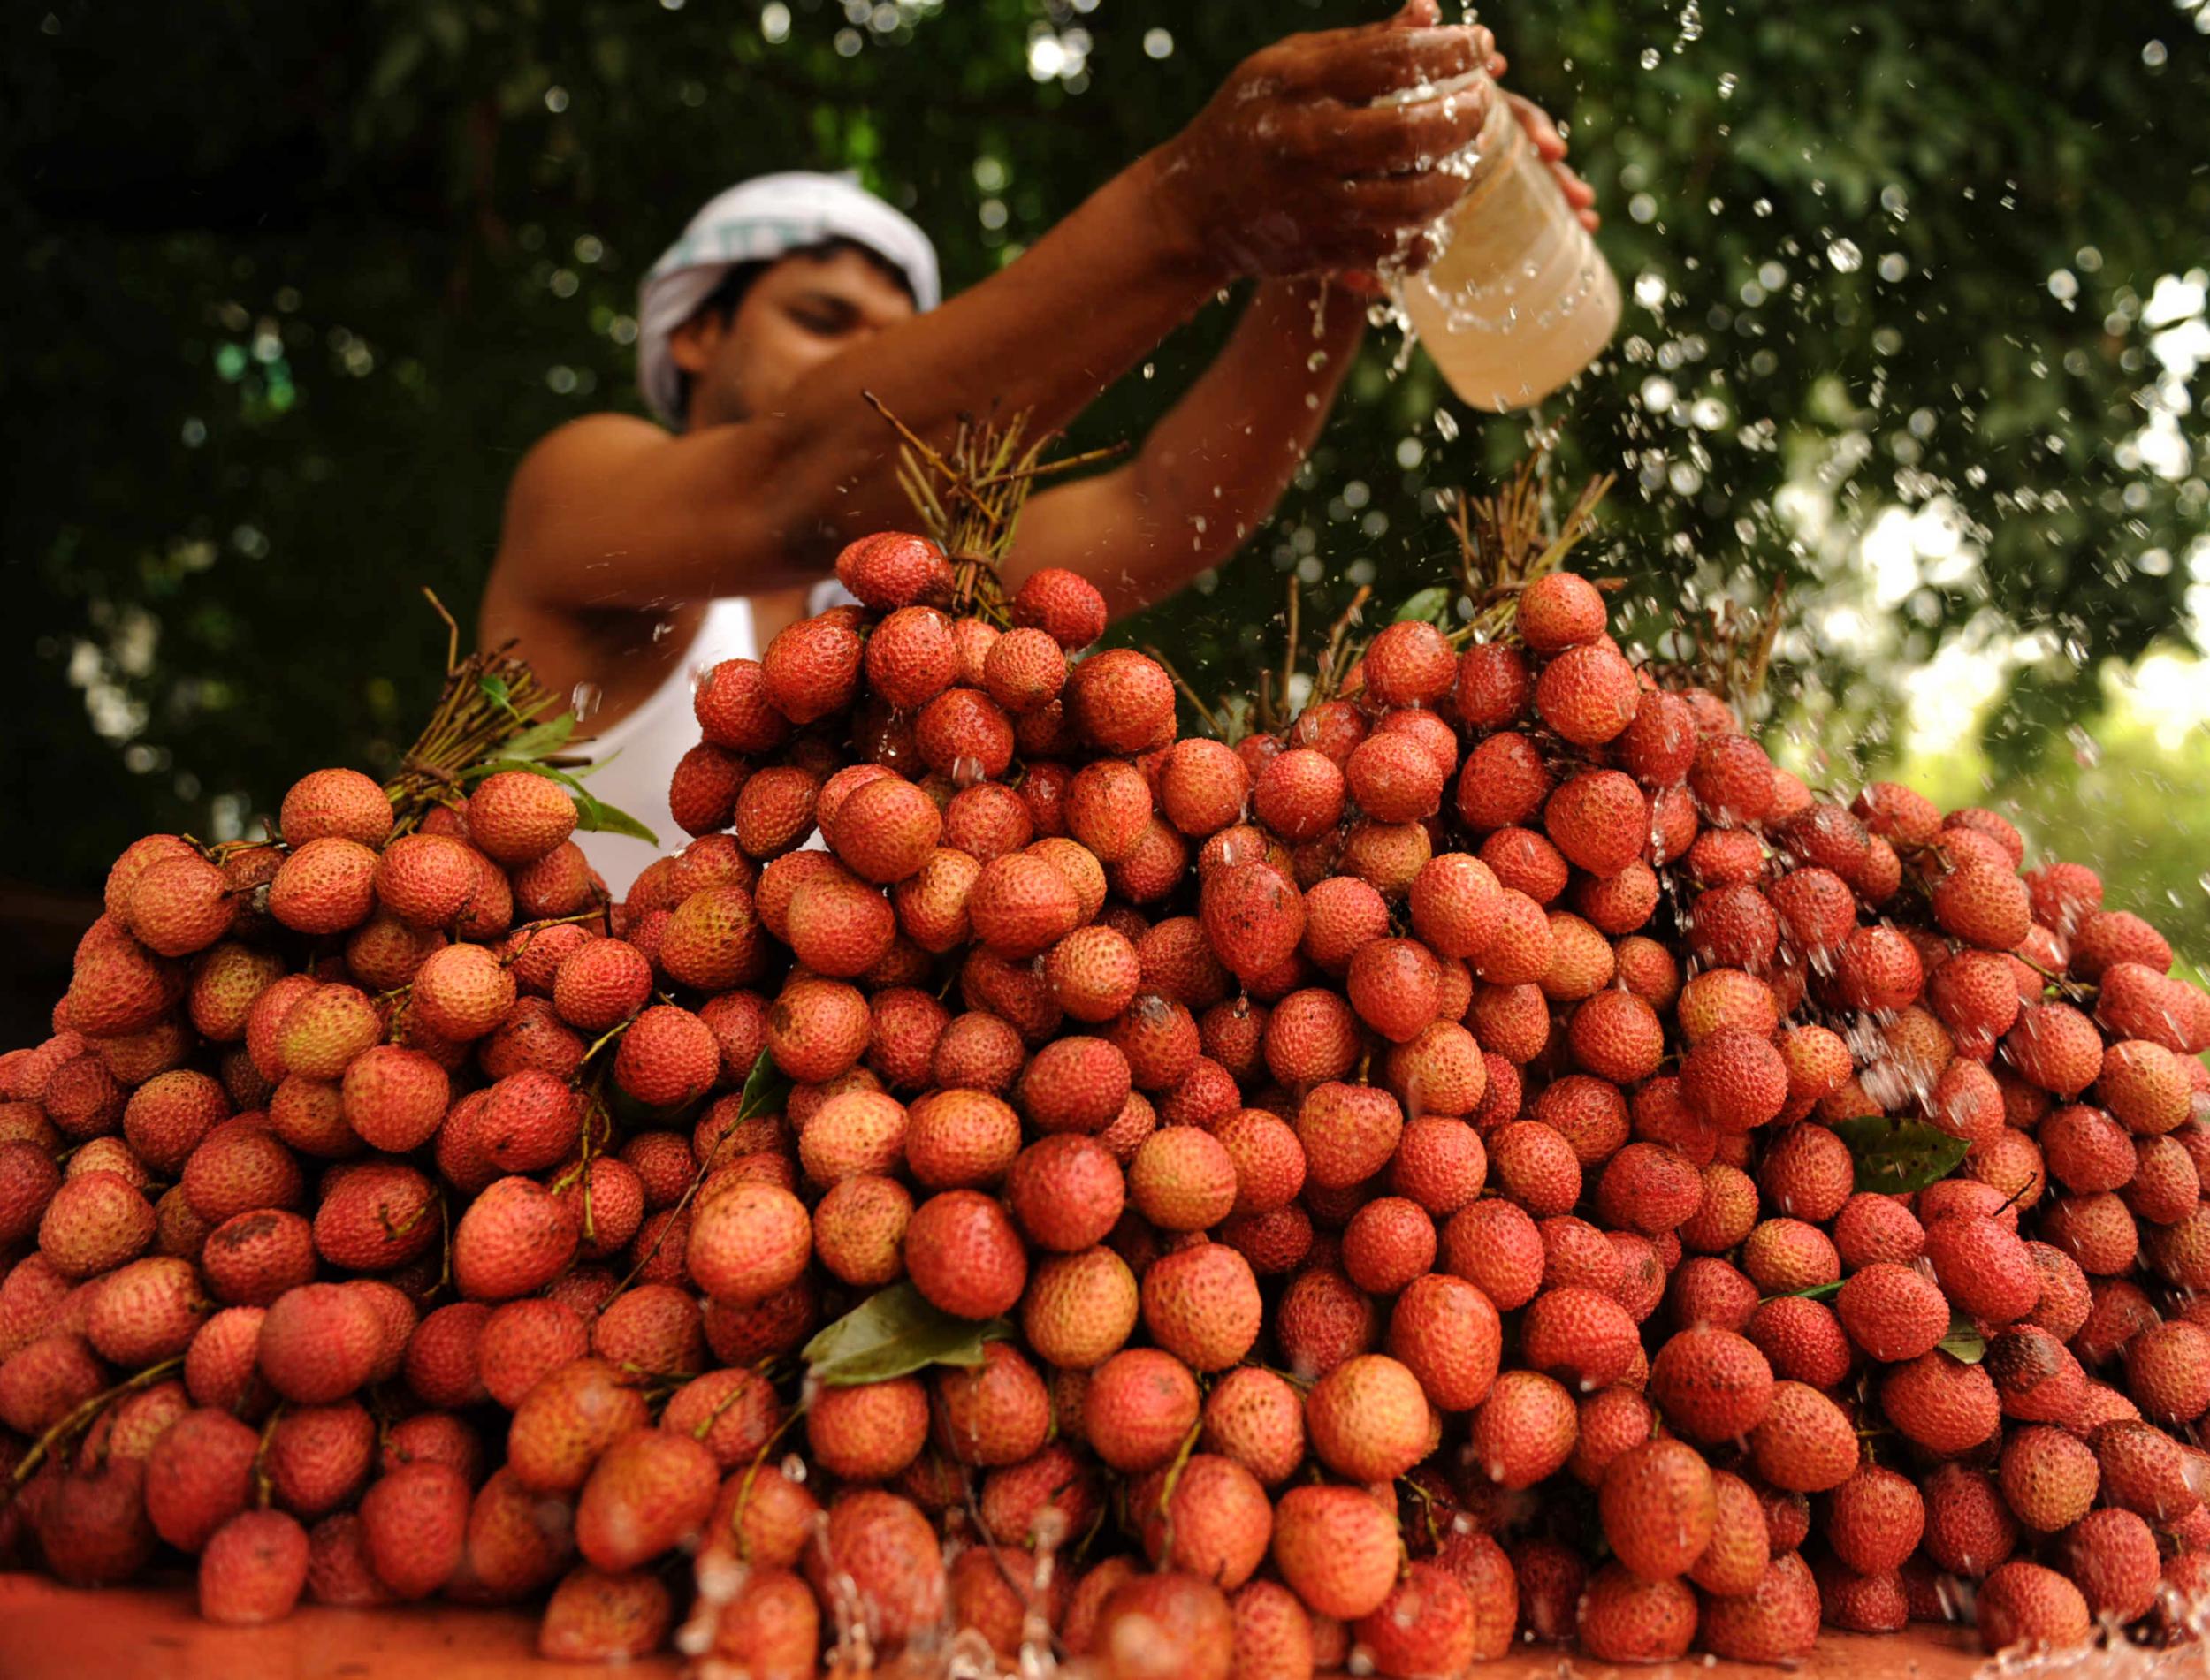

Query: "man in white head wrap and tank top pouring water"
left=482, top=0, right=1591, bottom=895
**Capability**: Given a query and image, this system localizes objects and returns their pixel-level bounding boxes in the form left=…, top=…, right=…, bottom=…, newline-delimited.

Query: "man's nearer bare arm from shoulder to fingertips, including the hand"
left=499, top=25, right=1490, bottom=610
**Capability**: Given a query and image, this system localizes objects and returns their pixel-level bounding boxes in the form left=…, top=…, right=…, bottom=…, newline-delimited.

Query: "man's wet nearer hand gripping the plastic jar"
left=1154, top=0, right=1494, bottom=274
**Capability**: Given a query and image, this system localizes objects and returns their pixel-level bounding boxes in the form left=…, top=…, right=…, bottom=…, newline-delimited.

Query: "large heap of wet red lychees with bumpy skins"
left=0, top=521, right=2210, bottom=1680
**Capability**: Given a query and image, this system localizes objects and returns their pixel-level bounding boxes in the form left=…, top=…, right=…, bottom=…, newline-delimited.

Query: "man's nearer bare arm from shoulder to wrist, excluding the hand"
left=502, top=168, right=1220, bottom=608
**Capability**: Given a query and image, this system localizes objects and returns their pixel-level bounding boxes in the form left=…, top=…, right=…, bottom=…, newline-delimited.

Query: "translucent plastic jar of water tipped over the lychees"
left=1386, top=73, right=1620, bottom=414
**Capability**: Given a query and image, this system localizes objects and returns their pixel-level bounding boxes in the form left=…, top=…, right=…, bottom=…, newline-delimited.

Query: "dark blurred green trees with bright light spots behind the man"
left=0, top=0, right=2210, bottom=955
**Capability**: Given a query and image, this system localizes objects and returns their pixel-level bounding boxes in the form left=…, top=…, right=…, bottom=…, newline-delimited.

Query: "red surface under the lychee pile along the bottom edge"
left=0, top=1574, right=2024, bottom=1680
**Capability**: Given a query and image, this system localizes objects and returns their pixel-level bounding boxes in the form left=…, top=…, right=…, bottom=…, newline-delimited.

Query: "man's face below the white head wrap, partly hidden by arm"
left=670, top=250, right=913, bottom=427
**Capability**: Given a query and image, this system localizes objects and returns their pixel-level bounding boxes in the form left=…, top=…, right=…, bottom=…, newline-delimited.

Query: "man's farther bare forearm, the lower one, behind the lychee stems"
left=1006, top=281, right=1366, bottom=617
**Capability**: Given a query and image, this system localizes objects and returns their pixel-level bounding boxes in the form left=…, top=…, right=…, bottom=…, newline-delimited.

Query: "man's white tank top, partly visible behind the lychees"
left=575, top=577, right=853, bottom=900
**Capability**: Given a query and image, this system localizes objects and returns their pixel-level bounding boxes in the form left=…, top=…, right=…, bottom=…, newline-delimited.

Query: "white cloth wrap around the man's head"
left=636, top=171, right=941, bottom=427
